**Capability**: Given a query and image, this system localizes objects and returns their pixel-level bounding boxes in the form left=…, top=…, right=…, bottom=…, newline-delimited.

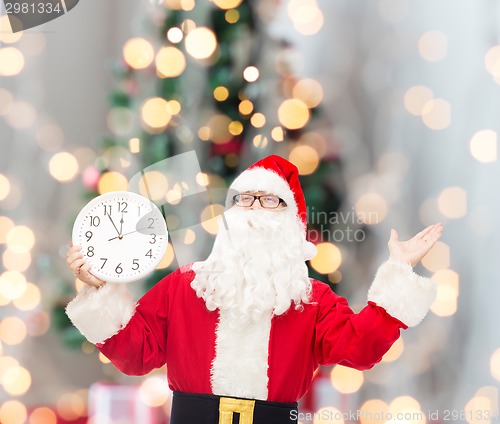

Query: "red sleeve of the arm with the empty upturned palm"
left=314, top=283, right=407, bottom=370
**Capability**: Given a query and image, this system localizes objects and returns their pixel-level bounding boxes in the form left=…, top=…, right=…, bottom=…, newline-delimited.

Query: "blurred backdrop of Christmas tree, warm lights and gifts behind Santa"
left=0, top=0, right=500, bottom=424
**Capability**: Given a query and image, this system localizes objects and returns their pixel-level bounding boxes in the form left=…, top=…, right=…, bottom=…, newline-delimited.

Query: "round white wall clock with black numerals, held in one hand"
left=72, top=191, right=168, bottom=283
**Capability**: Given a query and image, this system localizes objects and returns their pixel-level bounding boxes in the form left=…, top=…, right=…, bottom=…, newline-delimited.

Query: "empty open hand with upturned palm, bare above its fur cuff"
left=387, top=223, right=443, bottom=266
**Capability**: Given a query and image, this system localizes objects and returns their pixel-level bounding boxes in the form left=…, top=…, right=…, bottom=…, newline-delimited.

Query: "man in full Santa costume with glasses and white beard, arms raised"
left=67, top=156, right=442, bottom=424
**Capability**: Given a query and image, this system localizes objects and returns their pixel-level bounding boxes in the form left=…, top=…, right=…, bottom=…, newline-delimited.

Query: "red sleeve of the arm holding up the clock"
left=97, top=271, right=179, bottom=375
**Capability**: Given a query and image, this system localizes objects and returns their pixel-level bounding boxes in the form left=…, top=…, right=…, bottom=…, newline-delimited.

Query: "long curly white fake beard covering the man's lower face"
left=191, top=207, right=311, bottom=326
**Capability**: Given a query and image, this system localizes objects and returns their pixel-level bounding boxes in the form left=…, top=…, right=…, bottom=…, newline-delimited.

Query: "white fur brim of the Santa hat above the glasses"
left=230, top=167, right=298, bottom=215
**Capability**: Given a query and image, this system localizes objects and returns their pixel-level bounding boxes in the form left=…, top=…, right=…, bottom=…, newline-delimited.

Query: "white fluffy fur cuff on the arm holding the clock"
left=66, top=283, right=135, bottom=344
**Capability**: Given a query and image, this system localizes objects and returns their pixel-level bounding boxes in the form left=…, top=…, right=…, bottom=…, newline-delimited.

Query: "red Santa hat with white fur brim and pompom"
left=230, top=155, right=316, bottom=260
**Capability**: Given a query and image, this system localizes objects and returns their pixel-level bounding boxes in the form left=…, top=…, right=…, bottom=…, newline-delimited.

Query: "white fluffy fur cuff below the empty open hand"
left=368, top=260, right=437, bottom=327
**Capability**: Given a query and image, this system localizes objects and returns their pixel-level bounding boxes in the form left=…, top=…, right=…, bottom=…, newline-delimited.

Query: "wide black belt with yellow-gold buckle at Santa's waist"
left=170, top=392, right=298, bottom=424
